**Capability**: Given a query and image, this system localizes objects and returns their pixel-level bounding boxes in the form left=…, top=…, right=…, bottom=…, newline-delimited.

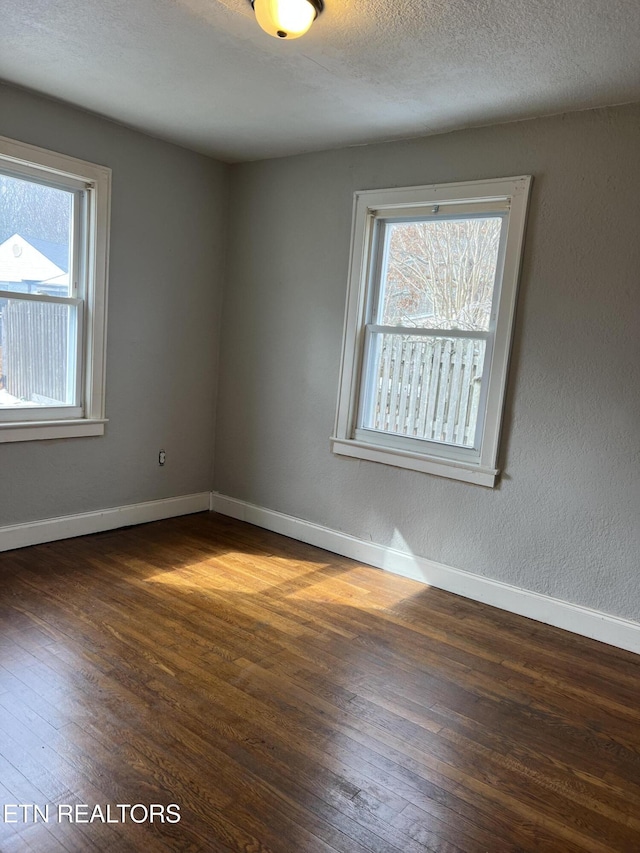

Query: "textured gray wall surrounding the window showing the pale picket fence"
left=214, top=106, right=640, bottom=619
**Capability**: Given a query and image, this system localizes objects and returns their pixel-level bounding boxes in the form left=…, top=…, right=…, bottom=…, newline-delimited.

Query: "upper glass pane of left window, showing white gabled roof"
left=0, top=175, right=74, bottom=296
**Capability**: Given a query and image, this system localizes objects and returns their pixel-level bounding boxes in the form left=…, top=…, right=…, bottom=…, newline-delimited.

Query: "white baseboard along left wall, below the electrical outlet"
left=0, top=492, right=210, bottom=551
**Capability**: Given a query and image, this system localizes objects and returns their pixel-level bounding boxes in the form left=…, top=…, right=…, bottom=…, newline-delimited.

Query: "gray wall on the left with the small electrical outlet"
left=0, top=86, right=227, bottom=526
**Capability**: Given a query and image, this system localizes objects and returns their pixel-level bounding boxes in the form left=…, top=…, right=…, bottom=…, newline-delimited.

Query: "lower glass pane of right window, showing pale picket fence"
left=362, top=333, right=486, bottom=447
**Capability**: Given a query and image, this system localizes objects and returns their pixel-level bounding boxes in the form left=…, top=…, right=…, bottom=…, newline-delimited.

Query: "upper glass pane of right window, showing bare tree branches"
left=377, top=216, right=502, bottom=331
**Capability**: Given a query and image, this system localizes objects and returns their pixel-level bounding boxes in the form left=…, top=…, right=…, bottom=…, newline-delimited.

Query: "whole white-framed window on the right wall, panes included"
left=331, top=176, right=531, bottom=486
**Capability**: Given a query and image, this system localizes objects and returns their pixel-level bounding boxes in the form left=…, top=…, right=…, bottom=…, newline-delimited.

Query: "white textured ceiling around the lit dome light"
left=0, top=0, right=640, bottom=162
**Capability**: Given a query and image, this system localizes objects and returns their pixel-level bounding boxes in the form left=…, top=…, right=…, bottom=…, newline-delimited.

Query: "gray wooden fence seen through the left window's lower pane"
left=1, top=299, right=69, bottom=402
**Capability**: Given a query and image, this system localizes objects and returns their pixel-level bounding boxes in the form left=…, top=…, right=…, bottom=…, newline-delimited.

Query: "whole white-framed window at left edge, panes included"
left=0, top=137, right=111, bottom=442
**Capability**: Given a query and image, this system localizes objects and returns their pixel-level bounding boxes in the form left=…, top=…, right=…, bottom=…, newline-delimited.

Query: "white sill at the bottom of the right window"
left=331, top=437, right=500, bottom=488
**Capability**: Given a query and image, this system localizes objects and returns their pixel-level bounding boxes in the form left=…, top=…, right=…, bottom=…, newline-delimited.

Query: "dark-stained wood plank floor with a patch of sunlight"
left=0, top=513, right=640, bottom=853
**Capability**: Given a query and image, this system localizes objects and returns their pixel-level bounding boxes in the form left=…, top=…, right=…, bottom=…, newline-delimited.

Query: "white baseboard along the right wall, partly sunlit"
left=211, top=492, right=640, bottom=653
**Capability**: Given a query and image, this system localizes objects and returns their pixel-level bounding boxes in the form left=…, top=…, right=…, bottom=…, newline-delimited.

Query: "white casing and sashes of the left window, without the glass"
left=0, top=137, right=111, bottom=443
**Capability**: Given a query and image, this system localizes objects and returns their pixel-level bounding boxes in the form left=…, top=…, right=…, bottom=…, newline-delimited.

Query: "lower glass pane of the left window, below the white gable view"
left=0, top=299, right=77, bottom=409
